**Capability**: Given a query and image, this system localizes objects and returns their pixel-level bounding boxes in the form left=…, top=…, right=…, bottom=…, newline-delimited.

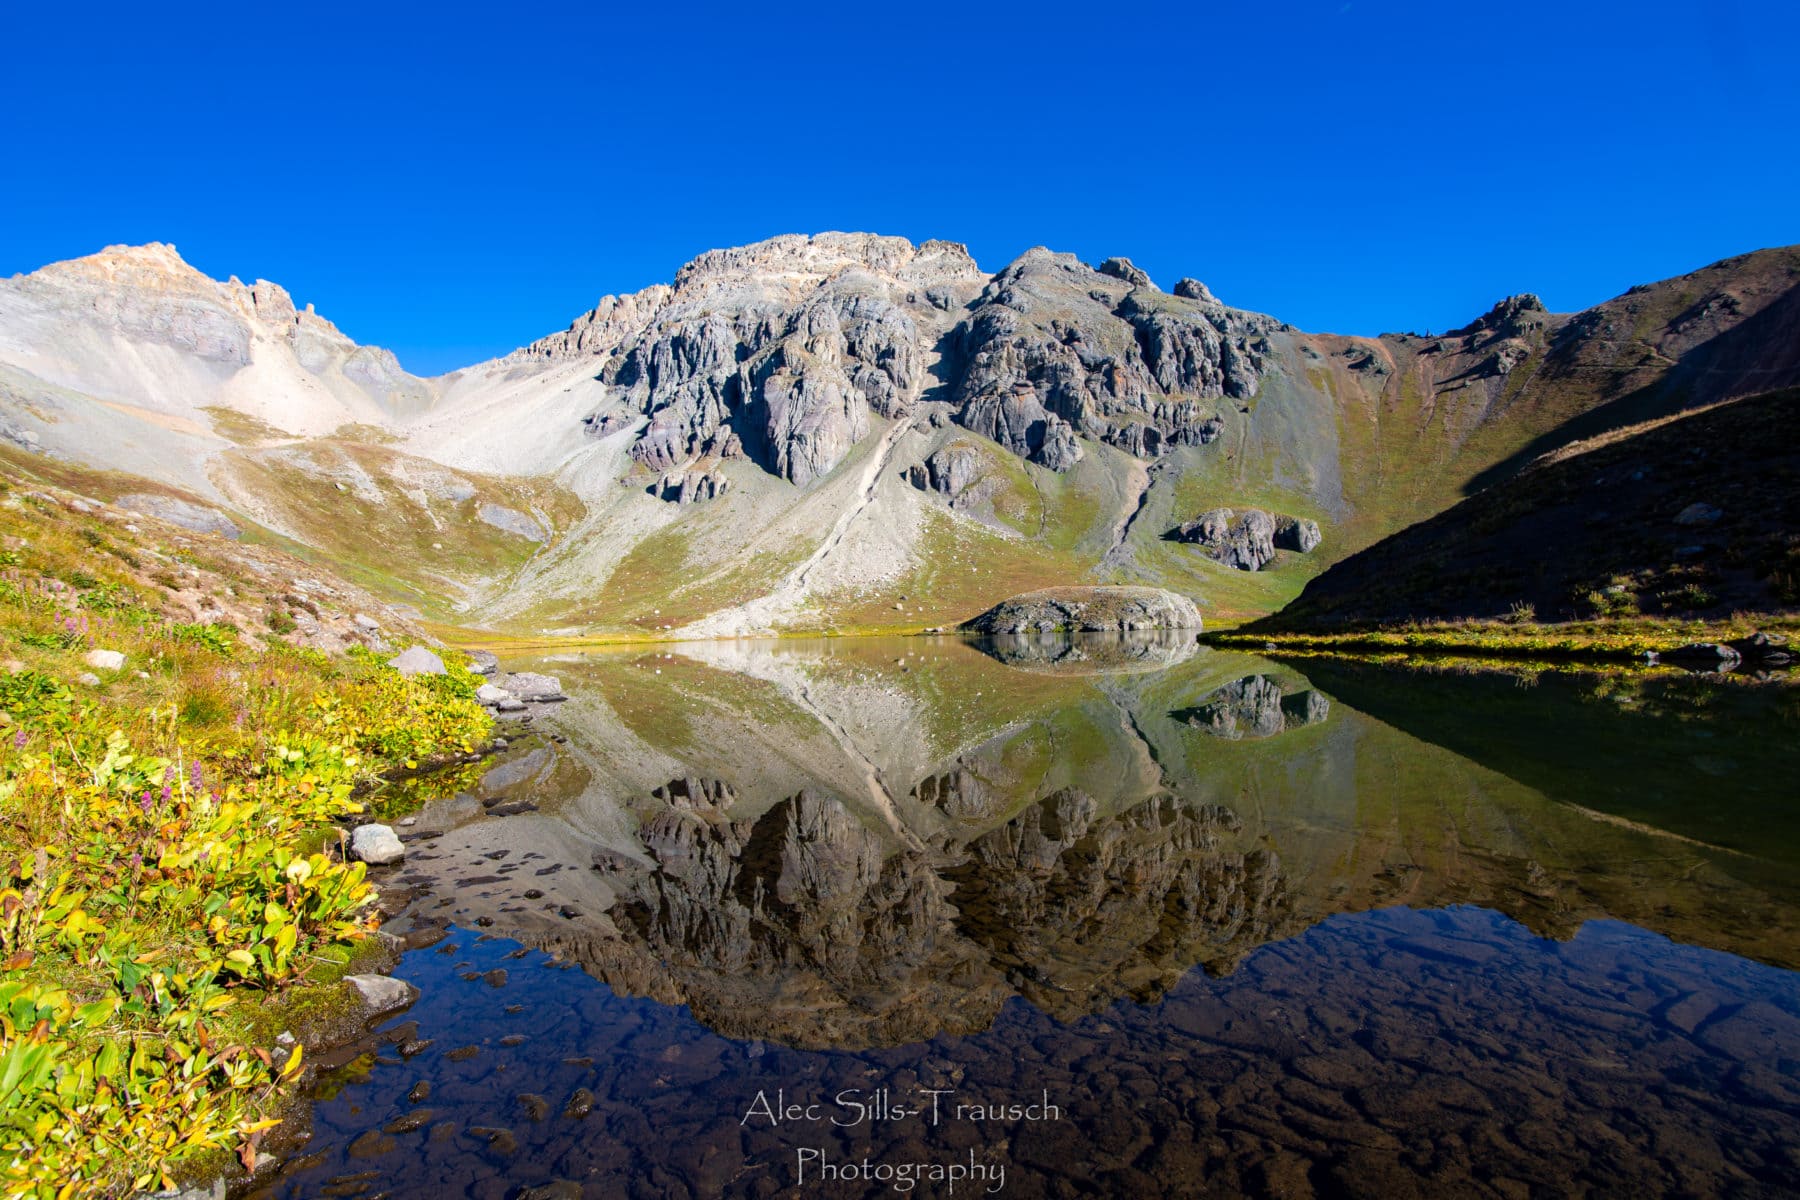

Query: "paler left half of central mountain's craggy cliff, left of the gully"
left=568, top=234, right=981, bottom=486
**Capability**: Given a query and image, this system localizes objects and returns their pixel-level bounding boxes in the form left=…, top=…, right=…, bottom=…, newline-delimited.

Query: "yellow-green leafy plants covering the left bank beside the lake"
left=0, top=484, right=491, bottom=1198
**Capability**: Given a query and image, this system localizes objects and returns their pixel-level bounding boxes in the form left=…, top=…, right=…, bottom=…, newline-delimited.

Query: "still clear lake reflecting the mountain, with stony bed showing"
left=270, top=640, right=1800, bottom=1196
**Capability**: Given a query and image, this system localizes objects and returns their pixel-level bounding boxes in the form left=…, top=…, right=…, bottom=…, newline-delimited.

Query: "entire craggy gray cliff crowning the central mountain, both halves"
left=518, top=234, right=1280, bottom=486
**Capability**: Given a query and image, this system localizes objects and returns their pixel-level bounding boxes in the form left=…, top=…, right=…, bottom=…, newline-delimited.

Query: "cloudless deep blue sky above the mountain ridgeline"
left=0, top=0, right=1800, bottom=372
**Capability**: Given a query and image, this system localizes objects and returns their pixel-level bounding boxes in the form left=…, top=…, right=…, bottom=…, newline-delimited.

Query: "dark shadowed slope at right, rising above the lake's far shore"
left=1262, top=389, right=1800, bottom=630
